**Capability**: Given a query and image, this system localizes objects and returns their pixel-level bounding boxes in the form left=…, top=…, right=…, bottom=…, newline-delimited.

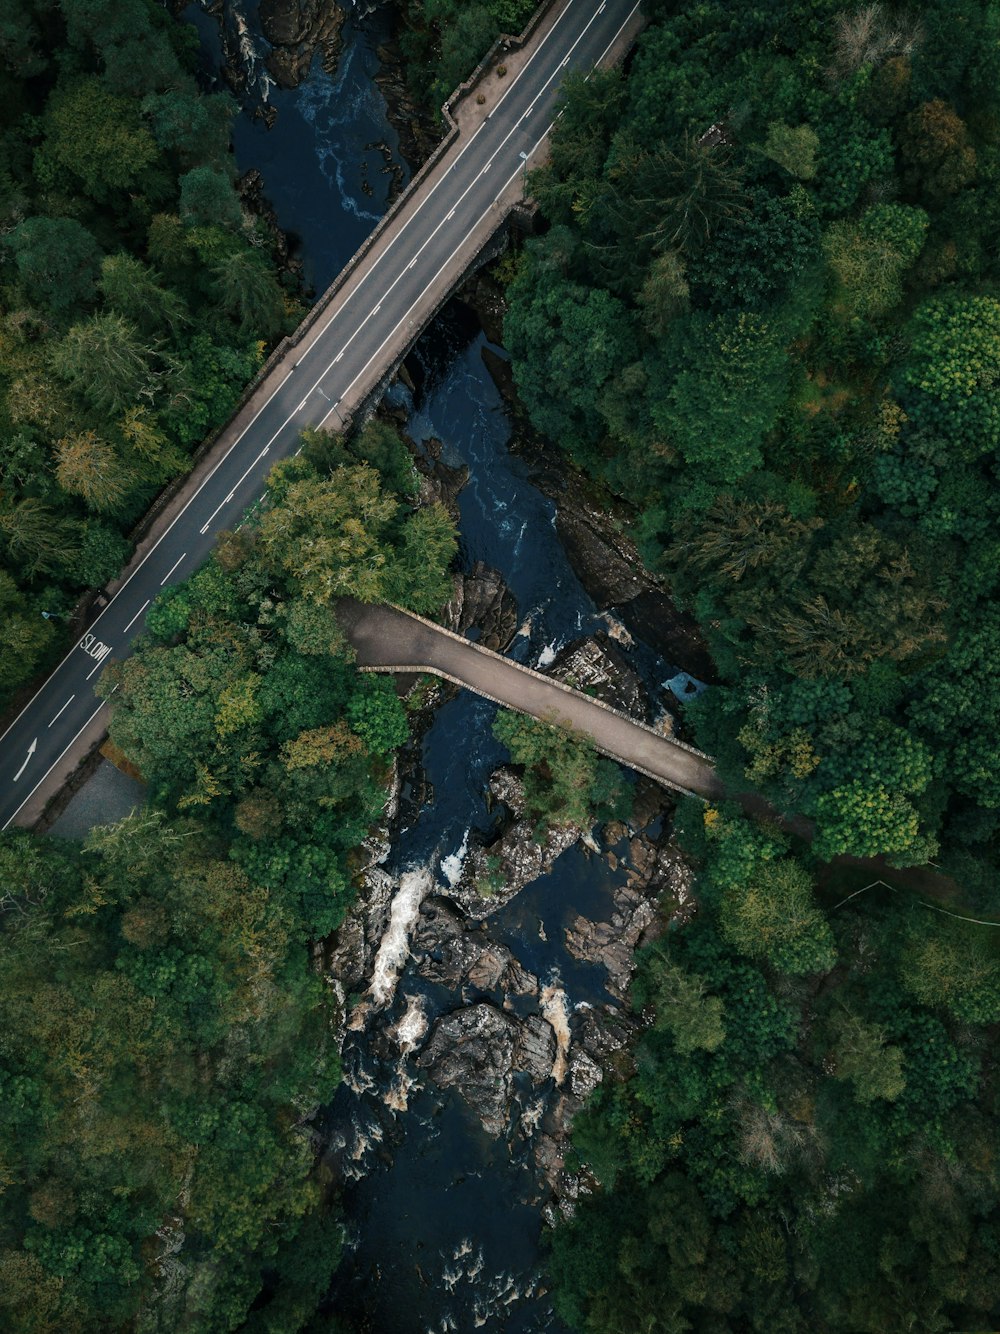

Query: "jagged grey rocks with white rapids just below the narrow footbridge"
left=327, top=658, right=691, bottom=1209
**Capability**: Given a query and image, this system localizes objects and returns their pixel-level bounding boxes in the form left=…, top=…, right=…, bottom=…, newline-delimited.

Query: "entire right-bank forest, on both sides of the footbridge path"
left=505, top=0, right=1000, bottom=1334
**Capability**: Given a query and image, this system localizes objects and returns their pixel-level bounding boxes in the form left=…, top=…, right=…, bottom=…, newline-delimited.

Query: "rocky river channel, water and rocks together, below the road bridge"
left=327, top=304, right=714, bottom=1334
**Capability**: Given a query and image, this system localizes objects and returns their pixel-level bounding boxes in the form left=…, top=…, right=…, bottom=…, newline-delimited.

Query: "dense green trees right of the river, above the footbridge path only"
left=505, top=0, right=1000, bottom=895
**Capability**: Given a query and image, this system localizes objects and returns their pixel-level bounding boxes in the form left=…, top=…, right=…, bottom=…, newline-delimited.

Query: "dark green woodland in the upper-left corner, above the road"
left=0, top=0, right=301, bottom=707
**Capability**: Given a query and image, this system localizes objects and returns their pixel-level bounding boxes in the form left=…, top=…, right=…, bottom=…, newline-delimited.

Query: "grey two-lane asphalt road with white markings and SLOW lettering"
left=0, top=0, right=639, bottom=828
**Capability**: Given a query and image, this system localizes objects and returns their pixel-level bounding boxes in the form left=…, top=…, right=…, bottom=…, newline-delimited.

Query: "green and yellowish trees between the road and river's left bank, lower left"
left=0, top=422, right=455, bottom=1334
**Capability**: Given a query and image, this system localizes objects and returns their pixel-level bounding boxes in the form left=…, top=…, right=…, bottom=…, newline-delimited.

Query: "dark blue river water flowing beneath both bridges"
left=187, top=7, right=671, bottom=1334
